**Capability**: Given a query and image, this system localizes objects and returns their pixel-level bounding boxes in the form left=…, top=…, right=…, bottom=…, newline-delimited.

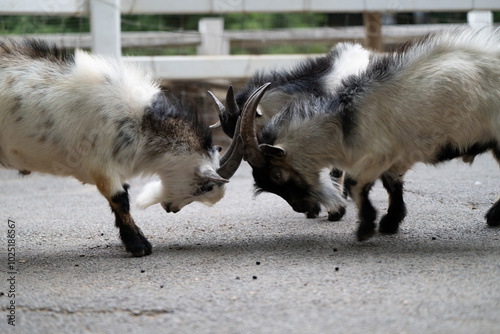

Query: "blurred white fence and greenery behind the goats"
left=0, top=0, right=500, bottom=144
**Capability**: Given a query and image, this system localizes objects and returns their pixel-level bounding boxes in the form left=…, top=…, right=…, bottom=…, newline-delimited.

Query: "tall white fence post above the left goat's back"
left=90, top=0, right=122, bottom=58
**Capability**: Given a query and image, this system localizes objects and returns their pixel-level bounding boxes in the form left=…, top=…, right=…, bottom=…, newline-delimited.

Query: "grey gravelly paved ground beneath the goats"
left=0, top=155, right=500, bottom=334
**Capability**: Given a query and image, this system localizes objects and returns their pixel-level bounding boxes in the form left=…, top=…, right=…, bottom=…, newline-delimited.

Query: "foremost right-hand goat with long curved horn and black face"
left=240, top=27, right=500, bottom=241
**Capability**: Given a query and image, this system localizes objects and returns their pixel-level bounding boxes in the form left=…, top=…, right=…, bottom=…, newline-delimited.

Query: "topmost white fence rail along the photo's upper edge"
left=0, top=0, right=500, bottom=15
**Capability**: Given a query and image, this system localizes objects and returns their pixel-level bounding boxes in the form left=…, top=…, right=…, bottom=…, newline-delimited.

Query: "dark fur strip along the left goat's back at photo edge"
left=0, top=38, right=75, bottom=63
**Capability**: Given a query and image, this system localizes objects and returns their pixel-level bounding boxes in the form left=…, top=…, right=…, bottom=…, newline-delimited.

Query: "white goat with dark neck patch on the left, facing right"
left=0, top=39, right=241, bottom=256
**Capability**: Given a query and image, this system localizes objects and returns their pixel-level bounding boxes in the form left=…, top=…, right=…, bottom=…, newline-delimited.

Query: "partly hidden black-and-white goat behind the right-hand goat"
left=209, top=43, right=372, bottom=221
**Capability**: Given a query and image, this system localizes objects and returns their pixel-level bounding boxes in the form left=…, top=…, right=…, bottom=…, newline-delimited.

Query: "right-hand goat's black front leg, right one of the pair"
left=378, top=172, right=406, bottom=234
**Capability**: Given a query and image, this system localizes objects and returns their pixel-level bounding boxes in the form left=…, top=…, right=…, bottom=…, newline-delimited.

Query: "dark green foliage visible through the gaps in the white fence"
left=0, top=12, right=500, bottom=55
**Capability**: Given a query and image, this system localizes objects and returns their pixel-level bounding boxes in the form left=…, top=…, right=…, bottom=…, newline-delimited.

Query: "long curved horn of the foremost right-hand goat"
left=240, top=82, right=271, bottom=167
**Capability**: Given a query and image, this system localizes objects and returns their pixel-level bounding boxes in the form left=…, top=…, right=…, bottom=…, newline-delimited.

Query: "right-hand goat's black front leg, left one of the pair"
left=349, top=179, right=377, bottom=241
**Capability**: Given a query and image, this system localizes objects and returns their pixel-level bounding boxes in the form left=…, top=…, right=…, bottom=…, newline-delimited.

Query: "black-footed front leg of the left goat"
left=94, top=177, right=153, bottom=257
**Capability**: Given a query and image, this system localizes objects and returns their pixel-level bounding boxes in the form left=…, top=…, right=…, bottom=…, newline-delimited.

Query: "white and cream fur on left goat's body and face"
left=0, top=45, right=224, bottom=208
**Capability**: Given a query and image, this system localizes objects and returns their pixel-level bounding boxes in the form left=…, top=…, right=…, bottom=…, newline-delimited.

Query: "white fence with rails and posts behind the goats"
left=0, top=0, right=500, bottom=80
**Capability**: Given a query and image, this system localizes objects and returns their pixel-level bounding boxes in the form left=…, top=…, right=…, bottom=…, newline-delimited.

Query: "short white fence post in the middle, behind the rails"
left=197, top=18, right=229, bottom=55
